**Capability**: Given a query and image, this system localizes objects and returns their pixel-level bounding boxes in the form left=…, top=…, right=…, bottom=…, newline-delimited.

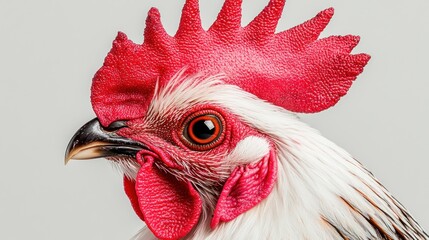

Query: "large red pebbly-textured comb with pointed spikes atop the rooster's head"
left=91, top=0, right=370, bottom=125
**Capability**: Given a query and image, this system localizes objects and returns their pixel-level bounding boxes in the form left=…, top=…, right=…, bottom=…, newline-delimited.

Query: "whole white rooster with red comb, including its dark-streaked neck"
left=66, top=0, right=428, bottom=240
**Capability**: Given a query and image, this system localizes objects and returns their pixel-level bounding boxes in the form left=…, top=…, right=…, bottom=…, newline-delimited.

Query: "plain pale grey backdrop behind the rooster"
left=0, top=0, right=429, bottom=240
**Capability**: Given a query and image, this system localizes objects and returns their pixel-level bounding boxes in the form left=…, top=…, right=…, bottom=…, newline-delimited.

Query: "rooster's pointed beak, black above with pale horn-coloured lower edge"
left=64, top=118, right=146, bottom=164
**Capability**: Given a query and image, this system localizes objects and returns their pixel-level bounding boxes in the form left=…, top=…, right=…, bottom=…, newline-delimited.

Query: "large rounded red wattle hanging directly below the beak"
left=135, top=157, right=202, bottom=240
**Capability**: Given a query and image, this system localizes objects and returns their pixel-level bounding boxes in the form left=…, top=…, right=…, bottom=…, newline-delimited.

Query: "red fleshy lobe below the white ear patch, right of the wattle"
left=210, top=150, right=277, bottom=228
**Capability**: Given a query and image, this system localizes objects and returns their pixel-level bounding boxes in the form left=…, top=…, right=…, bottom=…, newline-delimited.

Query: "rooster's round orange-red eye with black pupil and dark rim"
left=183, top=112, right=223, bottom=150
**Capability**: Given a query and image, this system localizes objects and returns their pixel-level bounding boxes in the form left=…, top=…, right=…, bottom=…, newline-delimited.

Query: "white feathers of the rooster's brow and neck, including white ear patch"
left=125, top=72, right=427, bottom=240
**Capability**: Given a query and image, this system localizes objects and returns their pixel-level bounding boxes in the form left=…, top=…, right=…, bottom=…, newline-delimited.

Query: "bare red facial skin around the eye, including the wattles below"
left=118, top=105, right=277, bottom=239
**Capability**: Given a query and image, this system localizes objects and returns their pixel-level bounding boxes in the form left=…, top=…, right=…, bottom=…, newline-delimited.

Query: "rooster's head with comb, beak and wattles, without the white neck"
left=66, top=0, right=369, bottom=239
